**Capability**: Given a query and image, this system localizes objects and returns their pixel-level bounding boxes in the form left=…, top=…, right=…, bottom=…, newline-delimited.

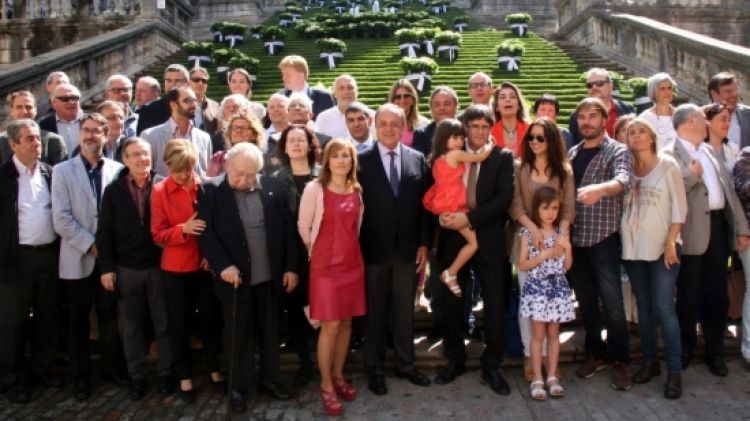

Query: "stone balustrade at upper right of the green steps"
left=558, top=9, right=750, bottom=103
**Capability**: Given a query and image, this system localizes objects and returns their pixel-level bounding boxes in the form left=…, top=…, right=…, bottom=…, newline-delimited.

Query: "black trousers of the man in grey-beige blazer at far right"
left=677, top=210, right=731, bottom=358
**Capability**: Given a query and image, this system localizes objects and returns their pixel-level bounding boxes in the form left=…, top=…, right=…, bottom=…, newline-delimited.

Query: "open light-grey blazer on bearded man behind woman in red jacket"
left=141, top=121, right=213, bottom=179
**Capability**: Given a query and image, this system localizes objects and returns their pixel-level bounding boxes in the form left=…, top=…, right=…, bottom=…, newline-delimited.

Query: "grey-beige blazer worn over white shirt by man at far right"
left=663, top=140, right=750, bottom=255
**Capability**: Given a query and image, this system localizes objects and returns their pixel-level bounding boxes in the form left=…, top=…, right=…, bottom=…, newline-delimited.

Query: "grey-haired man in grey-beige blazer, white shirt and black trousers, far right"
left=664, top=104, right=750, bottom=377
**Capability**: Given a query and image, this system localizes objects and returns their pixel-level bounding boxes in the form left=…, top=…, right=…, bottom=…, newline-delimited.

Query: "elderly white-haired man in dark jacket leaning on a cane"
left=198, top=143, right=299, bottom=412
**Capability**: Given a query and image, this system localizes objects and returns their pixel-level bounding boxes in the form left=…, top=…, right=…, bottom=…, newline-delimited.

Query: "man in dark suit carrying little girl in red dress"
left=435, top=105, right=514, bottom=395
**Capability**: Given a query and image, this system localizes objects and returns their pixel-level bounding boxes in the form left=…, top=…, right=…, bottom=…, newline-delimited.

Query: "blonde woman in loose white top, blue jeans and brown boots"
left=620, top=117, right=687, bottom=399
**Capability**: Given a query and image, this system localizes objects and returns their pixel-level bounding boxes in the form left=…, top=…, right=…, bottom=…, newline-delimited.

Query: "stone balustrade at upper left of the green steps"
left=0, top=19, right=186, bottom=125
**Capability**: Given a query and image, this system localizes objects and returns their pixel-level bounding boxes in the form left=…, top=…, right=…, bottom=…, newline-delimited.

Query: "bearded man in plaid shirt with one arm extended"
left=569, top=98, right=633, bottom=390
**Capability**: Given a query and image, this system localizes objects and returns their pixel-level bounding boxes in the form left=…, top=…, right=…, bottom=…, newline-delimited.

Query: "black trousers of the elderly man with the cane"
left=222, top=281, right=279, bottom=393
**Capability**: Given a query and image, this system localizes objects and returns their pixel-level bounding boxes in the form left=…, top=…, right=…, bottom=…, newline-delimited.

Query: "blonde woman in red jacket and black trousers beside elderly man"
left=151, top=139, right=223, bottom=403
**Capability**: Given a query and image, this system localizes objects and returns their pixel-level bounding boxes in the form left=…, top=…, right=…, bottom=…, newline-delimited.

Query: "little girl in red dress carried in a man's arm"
left=422, top=118, right=494, bottom=297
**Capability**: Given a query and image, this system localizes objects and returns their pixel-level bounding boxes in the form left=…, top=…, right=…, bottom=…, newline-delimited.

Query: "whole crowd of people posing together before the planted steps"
left=0, top=55, right=750, bottom=415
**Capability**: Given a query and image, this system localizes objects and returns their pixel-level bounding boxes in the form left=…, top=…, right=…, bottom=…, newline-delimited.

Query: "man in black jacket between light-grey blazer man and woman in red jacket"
left=96, top=137, right=175, bottom=400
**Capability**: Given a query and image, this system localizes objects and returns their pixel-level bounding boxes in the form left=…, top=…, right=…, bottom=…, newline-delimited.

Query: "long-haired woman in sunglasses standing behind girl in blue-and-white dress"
left=510, top=117, right=575, bottom=381
